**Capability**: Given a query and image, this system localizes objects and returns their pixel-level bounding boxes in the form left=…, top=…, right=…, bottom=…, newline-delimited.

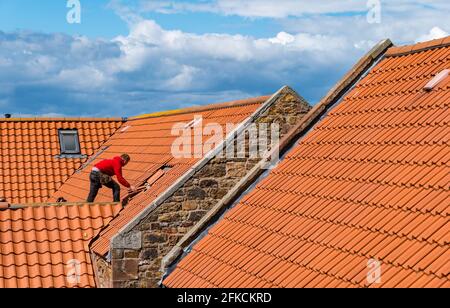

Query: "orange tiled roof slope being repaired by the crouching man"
left=52, top=96, right=269, bottom=256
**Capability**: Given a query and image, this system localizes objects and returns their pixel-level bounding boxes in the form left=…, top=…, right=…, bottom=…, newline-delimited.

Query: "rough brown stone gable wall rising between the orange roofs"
left=101, top=87, right=310, bottom=288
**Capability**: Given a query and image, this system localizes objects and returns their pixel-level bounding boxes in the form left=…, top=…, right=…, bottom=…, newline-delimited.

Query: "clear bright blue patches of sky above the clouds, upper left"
left=0, top=0, right=282, bottom=39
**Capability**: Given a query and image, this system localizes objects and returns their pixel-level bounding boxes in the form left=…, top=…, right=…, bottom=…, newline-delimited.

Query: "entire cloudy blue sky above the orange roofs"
left=0, top=0, right=450, bottom=116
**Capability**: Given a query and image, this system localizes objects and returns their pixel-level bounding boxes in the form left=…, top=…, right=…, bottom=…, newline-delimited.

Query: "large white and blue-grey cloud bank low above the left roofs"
left=0, top=19, right=359, bottom=116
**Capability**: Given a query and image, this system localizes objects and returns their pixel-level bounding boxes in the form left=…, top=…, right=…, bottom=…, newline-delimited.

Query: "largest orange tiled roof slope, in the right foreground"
left=164, top=38, right=450, bottom=288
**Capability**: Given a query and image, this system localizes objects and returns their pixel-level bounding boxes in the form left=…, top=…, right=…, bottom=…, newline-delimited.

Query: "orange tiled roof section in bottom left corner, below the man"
left=0, top=203, right=121, bottom=288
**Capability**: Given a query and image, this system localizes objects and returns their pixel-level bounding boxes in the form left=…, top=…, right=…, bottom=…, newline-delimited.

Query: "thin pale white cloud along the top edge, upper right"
left=133, top=0, right=450, bottom=49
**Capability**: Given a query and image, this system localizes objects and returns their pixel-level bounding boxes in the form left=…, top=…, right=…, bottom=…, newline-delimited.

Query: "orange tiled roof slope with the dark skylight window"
left=0, top=118, right=122, bottom=204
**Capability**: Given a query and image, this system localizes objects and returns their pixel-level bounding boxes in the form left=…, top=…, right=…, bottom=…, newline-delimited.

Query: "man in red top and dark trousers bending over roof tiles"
left=87, top=154, right=136, bottom=203
